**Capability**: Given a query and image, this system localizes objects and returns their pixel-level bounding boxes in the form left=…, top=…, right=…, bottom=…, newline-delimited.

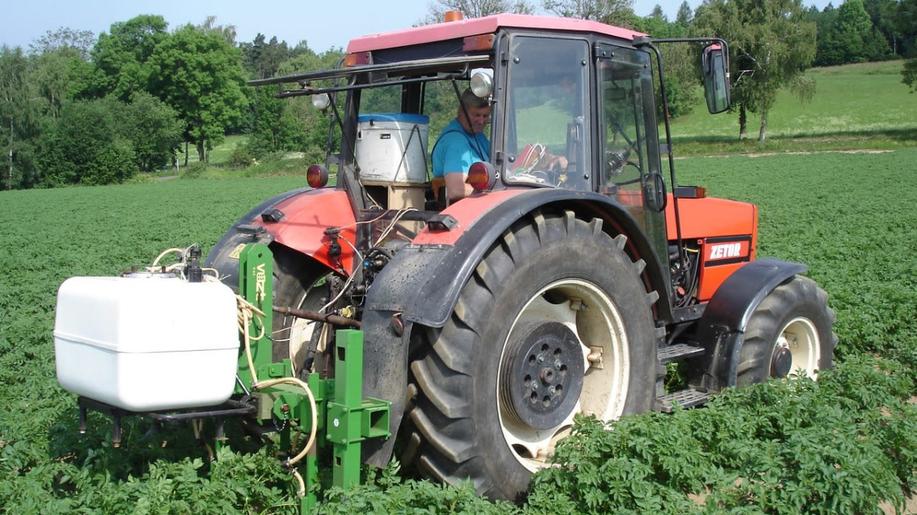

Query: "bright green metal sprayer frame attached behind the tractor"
left=235, top=243, right=391, bottom=513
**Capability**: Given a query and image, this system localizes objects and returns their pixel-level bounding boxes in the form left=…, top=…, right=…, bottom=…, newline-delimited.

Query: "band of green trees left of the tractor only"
left=0, top=15, right=342, bottom=189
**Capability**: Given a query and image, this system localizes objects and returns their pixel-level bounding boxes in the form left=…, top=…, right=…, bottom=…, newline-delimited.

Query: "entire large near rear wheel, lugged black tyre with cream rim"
left=408, top=211, right=659, bottom=500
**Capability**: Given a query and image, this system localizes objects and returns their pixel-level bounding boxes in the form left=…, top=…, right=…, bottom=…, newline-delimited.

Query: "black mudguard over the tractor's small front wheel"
left=698, top=259, right=807, bottom=391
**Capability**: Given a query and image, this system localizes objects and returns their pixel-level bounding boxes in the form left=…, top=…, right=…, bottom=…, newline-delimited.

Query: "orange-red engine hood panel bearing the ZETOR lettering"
left=665, top=194, right=758, bottom=302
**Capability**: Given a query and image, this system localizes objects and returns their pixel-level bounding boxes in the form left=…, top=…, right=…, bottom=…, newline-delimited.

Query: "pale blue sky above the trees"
left=0, top=0, right=840, bottom=51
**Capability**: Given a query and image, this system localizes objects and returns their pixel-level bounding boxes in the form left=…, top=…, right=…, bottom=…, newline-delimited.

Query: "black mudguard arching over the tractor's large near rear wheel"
left=363, top=189, right=672, bottom=466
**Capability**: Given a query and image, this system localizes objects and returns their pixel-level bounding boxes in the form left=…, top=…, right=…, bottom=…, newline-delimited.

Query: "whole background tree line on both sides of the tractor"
left=0, top=0, right=917, bottom=189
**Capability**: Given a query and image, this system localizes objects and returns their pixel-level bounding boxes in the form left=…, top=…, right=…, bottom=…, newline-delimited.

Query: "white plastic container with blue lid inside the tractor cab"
left=356, top=113, right=430, bottom=184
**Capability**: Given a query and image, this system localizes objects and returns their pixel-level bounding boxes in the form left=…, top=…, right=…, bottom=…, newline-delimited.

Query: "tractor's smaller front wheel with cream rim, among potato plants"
left=736, top=276, right=837, bottom=386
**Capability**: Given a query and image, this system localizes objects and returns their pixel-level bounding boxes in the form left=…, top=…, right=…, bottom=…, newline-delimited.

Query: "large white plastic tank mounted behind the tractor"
left=54, top=274, right=239, bottom=411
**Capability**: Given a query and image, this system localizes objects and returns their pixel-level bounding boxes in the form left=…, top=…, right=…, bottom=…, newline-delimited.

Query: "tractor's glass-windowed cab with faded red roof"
left=253, top=14, right=728, bottom=282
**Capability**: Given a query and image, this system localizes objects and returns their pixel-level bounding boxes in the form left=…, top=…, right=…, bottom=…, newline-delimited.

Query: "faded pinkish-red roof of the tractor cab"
left=347, top=14, right=645, bottom=53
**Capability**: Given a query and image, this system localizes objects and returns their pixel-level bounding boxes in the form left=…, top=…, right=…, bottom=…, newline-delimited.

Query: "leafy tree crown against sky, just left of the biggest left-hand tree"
left=90, top=15, right=169, bottom=102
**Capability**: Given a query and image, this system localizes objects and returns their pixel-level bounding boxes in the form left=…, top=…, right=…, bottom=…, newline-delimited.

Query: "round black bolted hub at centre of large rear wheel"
left=502, top=322, right=584, bottom=429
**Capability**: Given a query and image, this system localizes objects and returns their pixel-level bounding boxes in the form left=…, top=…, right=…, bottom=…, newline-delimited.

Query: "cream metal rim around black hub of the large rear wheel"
left=497, top=279, right=630, bottom=472
